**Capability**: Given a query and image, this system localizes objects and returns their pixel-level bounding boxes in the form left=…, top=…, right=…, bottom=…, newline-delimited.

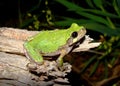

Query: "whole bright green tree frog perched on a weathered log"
left=24, top=23, right=86, bottom=66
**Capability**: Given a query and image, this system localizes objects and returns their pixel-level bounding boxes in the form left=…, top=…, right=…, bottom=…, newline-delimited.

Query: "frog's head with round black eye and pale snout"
left=70, top=23, right=86, bottom=45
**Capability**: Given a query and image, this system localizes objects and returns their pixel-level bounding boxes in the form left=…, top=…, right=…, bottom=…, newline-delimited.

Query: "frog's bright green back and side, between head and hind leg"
left=29, top=30, right=70, bottom=53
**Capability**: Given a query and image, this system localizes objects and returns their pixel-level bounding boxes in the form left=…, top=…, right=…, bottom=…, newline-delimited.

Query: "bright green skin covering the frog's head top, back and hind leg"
left=24, top=23, right=83, bottom=62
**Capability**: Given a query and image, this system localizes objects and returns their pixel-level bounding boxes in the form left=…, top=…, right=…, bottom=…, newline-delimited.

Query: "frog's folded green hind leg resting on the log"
left=24, top=42, right=43, bottom=64
